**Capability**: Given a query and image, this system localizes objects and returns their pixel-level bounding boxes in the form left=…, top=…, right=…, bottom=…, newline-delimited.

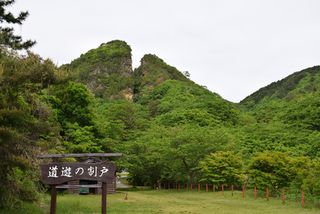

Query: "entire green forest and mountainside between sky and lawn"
left=0, top=1, right=320, bottom=210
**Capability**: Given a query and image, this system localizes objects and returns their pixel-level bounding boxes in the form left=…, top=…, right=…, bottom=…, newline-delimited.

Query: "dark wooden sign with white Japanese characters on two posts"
left=39, top=153, right=122, bottom=214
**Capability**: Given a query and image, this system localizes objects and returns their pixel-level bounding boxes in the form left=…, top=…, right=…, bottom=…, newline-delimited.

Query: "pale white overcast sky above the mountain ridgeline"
left=11, top=0, right=320, bottom=102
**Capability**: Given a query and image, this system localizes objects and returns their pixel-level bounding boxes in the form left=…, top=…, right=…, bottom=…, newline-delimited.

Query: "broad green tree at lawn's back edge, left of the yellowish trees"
left=127, top=123, right=235, bottom=185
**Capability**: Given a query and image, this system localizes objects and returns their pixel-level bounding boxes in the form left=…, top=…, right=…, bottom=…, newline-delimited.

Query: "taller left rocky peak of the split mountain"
left=62, top=40, right=133, bottom=98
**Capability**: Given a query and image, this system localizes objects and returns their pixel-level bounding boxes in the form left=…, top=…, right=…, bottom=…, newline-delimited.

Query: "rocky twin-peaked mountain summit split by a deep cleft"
left=62, top=40, right=190, bottom=101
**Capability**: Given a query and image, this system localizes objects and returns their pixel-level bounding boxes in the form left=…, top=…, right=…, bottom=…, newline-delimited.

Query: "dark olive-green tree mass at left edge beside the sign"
left=0, top=51, right=59, bottom=207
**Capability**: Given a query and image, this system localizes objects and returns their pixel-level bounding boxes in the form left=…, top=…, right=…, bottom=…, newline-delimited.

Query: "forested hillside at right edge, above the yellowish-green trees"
left=240, top=66, right=320, bottom=158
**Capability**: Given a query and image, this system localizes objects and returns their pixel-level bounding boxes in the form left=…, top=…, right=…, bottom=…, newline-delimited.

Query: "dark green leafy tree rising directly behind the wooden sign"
left=43, top=81, right=101, bottom=153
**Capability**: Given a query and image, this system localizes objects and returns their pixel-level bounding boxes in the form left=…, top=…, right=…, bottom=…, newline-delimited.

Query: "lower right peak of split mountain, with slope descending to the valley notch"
left=134, top=54, right=238, bottom=126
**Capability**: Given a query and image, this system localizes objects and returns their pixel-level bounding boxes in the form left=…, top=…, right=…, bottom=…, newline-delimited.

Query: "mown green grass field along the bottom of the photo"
left=0, top=190, right=320, bottom=214
